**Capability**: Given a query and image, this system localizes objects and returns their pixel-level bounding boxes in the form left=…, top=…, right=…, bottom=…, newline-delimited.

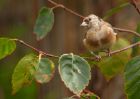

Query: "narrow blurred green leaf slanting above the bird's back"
left=103, top=2, right=130, bottom=20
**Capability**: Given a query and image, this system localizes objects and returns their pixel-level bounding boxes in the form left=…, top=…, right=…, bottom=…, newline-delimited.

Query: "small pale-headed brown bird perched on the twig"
left=81, top=14, right=117, bottom=60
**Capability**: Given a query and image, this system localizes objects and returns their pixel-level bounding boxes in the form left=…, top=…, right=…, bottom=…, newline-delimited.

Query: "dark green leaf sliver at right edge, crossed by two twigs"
left=131, top=23, right=140, bottom=57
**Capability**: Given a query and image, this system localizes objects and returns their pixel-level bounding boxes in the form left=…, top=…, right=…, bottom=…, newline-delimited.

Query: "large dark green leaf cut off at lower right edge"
left=124, top=56, right=140, bottom=99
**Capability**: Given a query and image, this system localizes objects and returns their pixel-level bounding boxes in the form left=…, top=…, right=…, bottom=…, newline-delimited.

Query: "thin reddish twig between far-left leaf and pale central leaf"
left=11, top=39, right=59, bottom=58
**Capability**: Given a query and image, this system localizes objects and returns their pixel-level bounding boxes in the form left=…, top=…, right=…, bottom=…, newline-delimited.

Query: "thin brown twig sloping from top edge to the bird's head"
left=48, top=0, right=85, bottom=19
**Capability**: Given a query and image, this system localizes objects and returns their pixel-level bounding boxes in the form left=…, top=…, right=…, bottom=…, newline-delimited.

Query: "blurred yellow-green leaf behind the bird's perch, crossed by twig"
left=98, top=38, right=131, bottom=80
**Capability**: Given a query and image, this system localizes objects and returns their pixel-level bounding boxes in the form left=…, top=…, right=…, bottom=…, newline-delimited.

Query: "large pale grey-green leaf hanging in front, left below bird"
left=59, top=54, right=91, bottom=96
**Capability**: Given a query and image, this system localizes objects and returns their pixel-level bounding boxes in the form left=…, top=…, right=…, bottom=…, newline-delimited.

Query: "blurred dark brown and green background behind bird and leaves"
left=0, top=0, right=140, bottom=99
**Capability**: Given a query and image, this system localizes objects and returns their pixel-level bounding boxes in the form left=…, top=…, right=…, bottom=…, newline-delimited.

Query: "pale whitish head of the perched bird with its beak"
left=81, top=14, right=102, bottom=30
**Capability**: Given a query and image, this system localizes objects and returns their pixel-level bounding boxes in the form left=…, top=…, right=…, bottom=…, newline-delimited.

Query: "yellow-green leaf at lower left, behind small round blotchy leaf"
left=12, top=54, right=38, bottom=94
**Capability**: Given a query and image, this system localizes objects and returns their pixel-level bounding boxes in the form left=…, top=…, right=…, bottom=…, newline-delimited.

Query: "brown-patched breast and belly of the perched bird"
left=84, top=27, right=116, bottom=51
